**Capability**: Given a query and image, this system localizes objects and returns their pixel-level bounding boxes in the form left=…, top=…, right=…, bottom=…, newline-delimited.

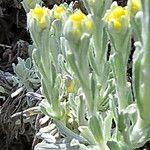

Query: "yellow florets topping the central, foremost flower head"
left=70, top=10, right=92, bottom=31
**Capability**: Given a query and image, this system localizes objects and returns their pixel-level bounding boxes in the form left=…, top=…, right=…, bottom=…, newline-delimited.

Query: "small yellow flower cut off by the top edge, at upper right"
left=131, top=0, right=141, bottom=13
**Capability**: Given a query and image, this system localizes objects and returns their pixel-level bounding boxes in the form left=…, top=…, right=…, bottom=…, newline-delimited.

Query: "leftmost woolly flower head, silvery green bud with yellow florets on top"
left=27, top=5, right=52, bottom=49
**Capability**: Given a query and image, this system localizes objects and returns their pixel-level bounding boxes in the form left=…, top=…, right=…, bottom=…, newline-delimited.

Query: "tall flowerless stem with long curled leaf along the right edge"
left=131, top=0, right=150, bottom=148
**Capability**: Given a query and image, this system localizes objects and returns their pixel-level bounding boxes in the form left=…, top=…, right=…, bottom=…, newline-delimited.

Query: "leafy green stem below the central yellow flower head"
left=68, top=43, right=96, bottom=115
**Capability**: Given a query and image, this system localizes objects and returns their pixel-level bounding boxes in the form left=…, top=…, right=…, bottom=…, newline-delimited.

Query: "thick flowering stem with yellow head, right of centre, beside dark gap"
left=104, top=2, right=131, bottom=109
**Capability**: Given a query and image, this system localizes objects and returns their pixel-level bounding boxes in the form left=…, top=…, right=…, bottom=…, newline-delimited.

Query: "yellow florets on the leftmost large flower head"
left=32, top=7, right=48, bottom=29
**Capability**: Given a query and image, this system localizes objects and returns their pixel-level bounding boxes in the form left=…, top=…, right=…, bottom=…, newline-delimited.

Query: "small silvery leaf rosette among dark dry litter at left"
left=11, top=53, right=41, bottom=106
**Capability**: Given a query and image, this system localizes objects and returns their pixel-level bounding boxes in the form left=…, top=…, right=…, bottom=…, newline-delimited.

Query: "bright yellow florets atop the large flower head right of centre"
left=104, top=6, right=129, bottom=30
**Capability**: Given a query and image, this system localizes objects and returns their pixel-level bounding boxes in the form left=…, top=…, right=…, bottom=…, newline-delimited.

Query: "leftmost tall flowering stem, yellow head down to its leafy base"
left=28, top=5, right=63, bottom=118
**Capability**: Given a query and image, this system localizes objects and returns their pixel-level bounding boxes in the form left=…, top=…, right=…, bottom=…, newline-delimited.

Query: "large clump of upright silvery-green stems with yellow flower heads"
left=17, top=0, right=150, bottom=150
